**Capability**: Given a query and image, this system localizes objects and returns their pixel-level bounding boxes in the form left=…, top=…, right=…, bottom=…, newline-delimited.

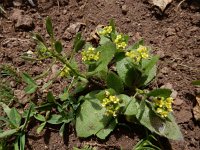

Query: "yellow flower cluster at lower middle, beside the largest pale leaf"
left=101, top=91, right=120, bottom=117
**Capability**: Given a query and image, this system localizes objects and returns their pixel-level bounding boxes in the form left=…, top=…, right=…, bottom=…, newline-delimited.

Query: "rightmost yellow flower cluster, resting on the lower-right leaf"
left=153, top=97, right=173, bottom=118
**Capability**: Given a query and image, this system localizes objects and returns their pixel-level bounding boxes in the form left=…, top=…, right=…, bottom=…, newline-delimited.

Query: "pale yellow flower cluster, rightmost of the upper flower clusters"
left=126, top=45, right=149, bottom=63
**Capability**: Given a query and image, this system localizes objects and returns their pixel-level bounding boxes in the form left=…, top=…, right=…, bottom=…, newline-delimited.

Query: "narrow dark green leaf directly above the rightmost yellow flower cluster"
left=147, top=89, right=172, bottom=98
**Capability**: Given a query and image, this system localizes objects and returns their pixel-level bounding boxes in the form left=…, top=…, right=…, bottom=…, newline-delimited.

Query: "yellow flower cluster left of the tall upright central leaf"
left=81, top=47, right=100, bottom=61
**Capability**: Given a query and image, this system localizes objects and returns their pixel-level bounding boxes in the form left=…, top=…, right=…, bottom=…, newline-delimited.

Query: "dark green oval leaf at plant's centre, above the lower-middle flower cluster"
left=106, top=71, right=124, bottom=93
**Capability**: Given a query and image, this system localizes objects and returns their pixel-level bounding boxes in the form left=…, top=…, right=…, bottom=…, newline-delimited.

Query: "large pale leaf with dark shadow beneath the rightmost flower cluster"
left=136, top=102, right=183, bottom=140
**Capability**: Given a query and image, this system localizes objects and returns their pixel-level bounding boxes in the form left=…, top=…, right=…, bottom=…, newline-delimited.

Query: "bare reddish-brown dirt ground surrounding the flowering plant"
left=0, top=0, right=200, bottom=150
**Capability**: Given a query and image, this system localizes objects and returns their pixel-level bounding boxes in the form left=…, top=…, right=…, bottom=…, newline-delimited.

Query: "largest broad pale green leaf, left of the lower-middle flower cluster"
left=76, top=91, right=113, bottom=137
